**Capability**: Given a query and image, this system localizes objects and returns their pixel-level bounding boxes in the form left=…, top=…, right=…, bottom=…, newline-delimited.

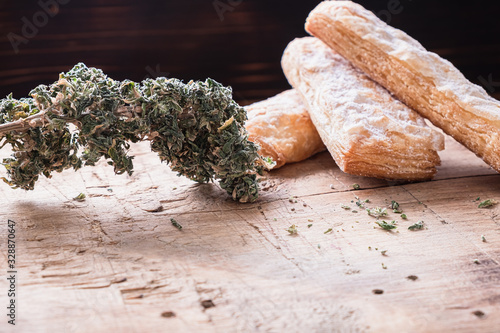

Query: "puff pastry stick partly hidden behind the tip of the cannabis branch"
left=245, top=89, right=325, bottom=169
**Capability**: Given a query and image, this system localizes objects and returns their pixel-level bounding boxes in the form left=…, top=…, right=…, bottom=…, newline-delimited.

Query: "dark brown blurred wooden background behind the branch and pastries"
left=0, top=0, right=500, bottom=105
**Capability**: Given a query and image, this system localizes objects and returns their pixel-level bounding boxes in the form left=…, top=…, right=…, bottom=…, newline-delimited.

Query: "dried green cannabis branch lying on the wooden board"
left=0, top=63, right=266, bottom=202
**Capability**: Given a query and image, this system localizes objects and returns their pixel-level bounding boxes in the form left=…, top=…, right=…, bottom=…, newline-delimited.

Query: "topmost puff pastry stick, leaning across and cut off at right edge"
left=306, top=1, right=500, bottom=171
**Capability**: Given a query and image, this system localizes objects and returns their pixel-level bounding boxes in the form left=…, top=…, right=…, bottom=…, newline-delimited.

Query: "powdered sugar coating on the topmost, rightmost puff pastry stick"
left=310, top=1, right=500, bottom=126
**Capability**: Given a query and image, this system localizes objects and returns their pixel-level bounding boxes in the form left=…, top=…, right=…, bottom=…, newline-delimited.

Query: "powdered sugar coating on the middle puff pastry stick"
left=282, top=37, right=444, bottom=152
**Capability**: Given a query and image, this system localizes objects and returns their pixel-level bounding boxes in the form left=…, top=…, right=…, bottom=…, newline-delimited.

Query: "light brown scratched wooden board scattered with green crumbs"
left=0, top=134, right=500, bottom=332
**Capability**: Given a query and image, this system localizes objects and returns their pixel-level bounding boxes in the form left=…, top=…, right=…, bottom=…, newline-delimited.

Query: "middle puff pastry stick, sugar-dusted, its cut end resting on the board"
left=282, top=37, right=444, bottom=180
